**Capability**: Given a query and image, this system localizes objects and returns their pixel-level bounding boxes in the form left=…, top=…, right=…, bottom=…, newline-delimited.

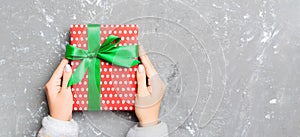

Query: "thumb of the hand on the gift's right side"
left=136, top=64, right=149, bottom=96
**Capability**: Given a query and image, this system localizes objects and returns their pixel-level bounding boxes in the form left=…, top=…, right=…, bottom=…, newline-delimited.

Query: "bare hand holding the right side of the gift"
left=135, top=50, right=165, bottom=126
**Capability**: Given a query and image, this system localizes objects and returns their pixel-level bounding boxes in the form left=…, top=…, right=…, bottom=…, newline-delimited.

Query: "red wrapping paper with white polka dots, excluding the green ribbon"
left=70, top=25, right=138, bottom=111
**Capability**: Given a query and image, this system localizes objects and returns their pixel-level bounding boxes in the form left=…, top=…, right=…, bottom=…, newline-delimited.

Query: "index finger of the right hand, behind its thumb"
left=139, top=49, right=157, bottom=78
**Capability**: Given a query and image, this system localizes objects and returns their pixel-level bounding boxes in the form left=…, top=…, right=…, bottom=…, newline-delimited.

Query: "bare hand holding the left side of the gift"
left=45, top=59, right=73, bottom=121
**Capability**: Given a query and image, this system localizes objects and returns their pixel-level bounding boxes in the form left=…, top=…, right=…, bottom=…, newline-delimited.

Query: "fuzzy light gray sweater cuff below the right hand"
left=127, top=122, right=168, bottom=137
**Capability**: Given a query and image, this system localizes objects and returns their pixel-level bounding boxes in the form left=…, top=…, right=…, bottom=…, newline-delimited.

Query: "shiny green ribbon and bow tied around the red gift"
left=65, top=24, right=140, bottom=110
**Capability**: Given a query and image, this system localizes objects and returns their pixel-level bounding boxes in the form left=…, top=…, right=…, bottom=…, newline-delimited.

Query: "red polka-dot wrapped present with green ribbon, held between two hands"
left=66, top=24, right=140, bottom=111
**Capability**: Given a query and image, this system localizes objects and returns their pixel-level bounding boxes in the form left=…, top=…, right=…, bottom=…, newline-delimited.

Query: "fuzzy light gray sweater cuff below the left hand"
left=38, top=116, right=78, bottom=137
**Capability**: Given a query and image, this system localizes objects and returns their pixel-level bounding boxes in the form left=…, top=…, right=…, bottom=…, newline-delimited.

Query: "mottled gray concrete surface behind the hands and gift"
left=0, top=0, right=300, bottom=137
